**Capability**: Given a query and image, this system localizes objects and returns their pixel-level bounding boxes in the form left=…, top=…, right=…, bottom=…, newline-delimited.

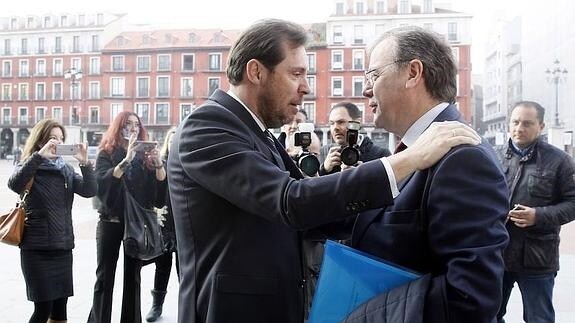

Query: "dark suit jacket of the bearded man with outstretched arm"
left=168, top=90, right=392, bottom=323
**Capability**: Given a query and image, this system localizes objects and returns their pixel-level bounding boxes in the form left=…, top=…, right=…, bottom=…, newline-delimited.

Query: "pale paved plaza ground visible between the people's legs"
left=0, top=160, right=575, bottom=323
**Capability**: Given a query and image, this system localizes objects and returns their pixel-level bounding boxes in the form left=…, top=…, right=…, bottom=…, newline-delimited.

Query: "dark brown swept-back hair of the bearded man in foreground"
left=226, top=19, right=307, bottom=85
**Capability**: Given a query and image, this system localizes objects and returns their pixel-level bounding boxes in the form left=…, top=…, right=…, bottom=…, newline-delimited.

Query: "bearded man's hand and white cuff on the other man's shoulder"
left=387, top=121, right=481, bottom=182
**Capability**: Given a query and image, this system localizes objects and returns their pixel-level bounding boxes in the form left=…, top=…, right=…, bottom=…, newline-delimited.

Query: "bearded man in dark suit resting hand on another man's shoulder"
left=168, top=19, right=479, bottom=323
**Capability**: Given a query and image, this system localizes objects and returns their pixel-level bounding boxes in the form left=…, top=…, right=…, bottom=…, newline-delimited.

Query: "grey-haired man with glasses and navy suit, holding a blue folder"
left=352, top=26, right=509, bottom=323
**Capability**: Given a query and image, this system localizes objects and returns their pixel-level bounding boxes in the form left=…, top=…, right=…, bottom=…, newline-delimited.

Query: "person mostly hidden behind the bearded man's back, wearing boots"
left=146, top=128, right=179, bottom=322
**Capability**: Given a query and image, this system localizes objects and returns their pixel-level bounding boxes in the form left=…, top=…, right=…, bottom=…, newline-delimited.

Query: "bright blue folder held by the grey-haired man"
left=309, top=240, right=421, bottom=323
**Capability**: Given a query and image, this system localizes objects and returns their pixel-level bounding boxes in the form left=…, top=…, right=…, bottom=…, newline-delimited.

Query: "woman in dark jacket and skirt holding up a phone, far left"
left=8, top=119, right=96, bottom=323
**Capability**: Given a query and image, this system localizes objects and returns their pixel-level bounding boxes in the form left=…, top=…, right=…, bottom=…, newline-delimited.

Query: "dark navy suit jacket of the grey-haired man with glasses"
left=352, top=106, right=509, bottom=323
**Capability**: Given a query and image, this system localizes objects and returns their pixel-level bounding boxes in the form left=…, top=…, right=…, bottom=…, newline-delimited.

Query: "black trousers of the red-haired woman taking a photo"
left=88, top=221, right=142, bottom=323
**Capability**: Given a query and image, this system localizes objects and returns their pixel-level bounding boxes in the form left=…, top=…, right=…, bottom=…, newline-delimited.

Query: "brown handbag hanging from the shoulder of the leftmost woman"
left=0, top=178, right=34, bottom=246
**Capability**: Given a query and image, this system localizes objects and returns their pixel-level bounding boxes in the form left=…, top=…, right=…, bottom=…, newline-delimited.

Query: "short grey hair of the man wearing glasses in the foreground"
left=371, top=26, right=457, bottom=103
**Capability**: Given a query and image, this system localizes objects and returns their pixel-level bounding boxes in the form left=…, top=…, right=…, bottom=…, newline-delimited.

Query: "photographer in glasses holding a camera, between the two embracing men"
left=319, top=102, right=391, bottom=176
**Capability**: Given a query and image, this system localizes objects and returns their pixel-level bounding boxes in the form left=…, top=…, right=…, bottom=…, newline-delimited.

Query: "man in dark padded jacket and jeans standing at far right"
left=497, top=101, right=575, bottom=323
